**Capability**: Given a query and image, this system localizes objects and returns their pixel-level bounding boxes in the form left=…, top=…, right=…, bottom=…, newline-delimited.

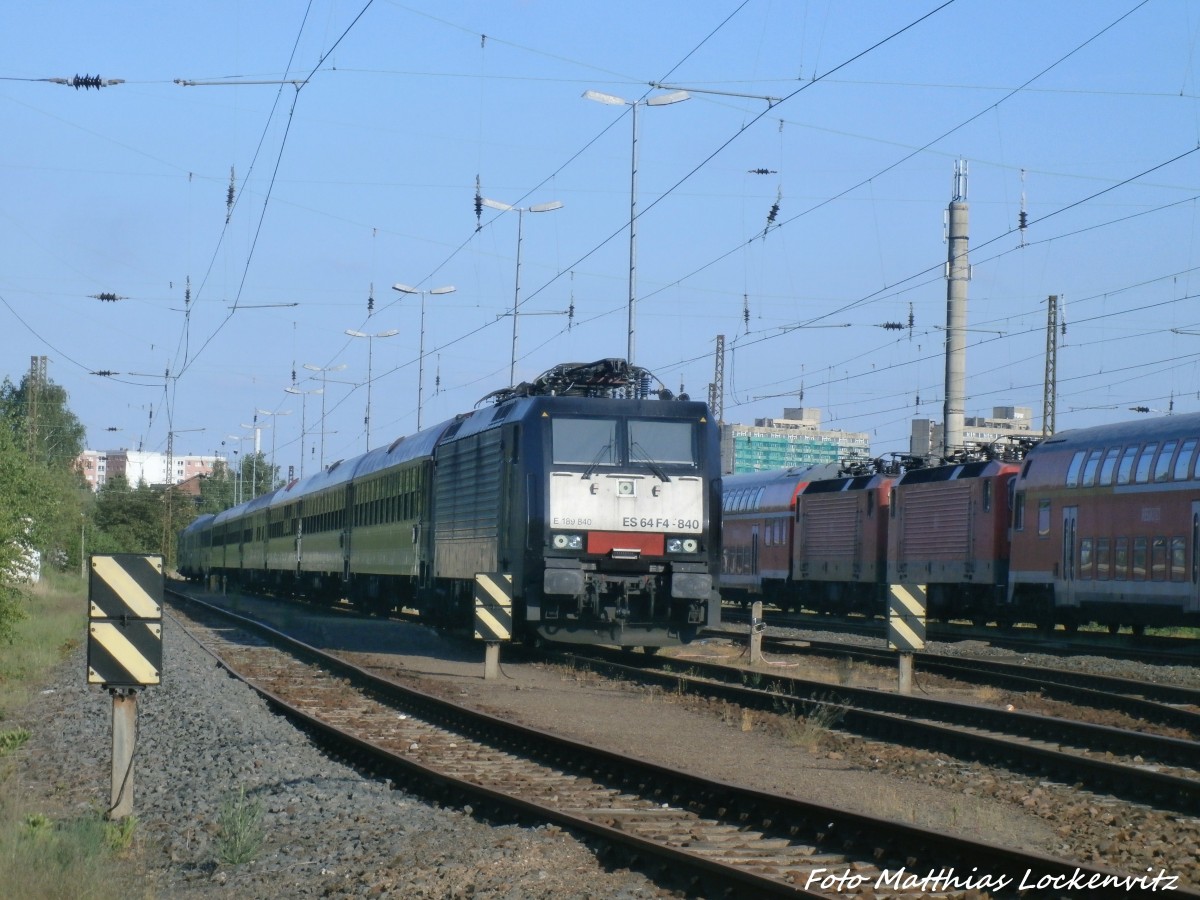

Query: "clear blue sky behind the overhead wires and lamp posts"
left=0, top=0, right=1200, bottom=472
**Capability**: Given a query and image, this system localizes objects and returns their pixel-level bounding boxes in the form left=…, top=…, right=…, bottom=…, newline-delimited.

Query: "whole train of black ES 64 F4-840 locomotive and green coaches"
left=180, top=359, right=721, bottom=648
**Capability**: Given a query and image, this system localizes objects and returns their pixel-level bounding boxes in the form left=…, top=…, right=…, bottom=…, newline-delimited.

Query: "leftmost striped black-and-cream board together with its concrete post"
left=88, top=553, right=163, bottom=818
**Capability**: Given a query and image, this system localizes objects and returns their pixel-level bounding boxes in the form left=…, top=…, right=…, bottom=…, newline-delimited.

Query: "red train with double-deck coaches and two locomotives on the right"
left=722, top=414, right=1200, bottom=634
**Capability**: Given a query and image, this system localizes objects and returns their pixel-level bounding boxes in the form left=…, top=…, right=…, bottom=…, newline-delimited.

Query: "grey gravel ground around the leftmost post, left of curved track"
left=9, top=619, right=659, bottom=899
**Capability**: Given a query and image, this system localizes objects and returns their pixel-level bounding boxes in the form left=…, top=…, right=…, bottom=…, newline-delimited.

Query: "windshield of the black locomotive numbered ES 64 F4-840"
left=551, top=418, right=697, bottom=467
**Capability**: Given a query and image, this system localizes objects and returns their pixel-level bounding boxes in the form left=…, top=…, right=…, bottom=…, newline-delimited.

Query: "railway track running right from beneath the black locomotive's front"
left=556, top=648, right=1200, bottom=815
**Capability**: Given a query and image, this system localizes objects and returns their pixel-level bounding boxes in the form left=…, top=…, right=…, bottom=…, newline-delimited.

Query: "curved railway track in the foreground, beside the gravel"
left=164, top=588, right=1166, bottom=896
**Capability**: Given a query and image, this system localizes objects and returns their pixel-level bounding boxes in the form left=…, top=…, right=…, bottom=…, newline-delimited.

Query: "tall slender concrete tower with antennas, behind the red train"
left=941, top=160, right=971, bottom=458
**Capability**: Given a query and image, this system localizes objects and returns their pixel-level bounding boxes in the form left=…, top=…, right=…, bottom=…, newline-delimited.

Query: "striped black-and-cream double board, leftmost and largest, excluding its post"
left=88, top=553, right=163, bottom=688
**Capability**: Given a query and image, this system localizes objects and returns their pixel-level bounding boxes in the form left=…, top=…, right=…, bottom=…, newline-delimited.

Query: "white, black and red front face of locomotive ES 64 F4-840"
left=536, top=401, right=719, bottom=647
